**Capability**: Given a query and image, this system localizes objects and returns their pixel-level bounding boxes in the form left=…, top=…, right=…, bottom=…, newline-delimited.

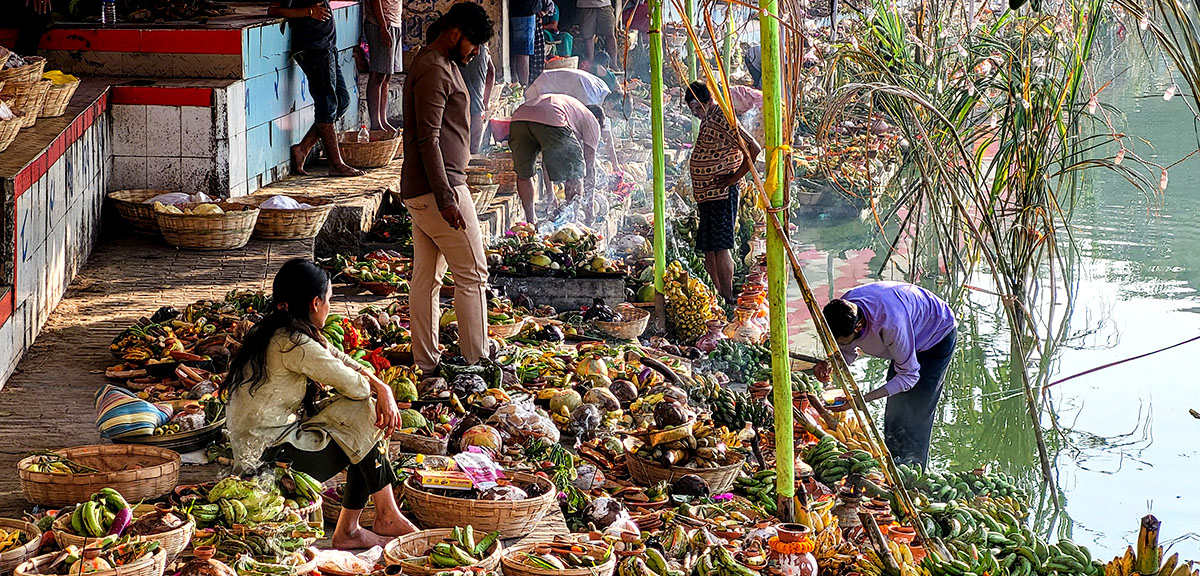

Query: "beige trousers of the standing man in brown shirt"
left=404, top=186, right=487, bottom=374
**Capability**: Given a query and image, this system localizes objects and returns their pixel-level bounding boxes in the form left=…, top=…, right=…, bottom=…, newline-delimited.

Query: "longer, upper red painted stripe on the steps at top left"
left=41, top=29, right=241, bottom=55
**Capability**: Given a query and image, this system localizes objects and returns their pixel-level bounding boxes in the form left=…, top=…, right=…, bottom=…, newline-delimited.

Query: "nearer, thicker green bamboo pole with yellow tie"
left=758, top=0, right=796, bottom=522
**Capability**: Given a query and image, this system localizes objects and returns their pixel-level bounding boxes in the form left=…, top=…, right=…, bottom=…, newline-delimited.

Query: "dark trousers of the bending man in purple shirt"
left=883, top=331, right=958, bottom=467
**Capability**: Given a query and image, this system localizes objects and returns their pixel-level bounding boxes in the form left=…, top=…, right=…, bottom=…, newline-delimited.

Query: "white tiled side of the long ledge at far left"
left=0, top=108, right=110, bottom=382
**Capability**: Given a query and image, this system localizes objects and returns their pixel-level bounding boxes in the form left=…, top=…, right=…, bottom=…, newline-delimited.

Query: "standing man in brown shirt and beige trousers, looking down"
left=400, top=1, right=493, bottom=373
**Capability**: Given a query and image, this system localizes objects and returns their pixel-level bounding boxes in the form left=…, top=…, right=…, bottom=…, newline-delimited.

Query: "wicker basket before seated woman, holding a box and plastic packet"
left=403, top=473, right=554, bottom=538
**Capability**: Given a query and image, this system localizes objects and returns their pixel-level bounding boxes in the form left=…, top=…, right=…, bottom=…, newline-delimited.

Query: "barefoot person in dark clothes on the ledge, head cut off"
left=266, top=0, right=362, bottom=176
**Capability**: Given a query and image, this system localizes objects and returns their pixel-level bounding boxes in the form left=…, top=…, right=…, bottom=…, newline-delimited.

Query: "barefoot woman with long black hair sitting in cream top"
left=223, top=258, right=416, bottom=550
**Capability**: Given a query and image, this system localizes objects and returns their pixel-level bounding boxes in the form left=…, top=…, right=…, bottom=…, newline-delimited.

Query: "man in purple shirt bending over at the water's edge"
left=814, top=282, right=958, bottom=466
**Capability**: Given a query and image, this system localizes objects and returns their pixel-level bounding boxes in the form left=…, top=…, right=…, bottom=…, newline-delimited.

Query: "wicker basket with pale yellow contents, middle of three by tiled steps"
left=155, top=203, right=258, bottom=250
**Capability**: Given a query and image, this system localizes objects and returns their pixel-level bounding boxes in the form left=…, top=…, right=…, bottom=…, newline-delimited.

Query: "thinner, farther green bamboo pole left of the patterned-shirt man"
left=649, top=0, right=667, bottom=328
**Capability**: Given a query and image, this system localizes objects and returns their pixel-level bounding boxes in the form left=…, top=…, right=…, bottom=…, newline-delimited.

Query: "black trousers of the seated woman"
left=263, top=440, right=396, bottom=510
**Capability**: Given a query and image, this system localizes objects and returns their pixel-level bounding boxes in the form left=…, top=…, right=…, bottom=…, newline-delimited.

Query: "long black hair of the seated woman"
left=222, top=258, right=329, bottom=394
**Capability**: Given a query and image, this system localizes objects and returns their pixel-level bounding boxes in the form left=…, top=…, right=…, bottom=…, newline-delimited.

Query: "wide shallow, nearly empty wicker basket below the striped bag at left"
left=17, top=444, right=180, bottom=506
